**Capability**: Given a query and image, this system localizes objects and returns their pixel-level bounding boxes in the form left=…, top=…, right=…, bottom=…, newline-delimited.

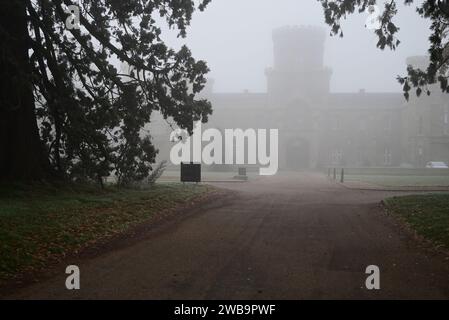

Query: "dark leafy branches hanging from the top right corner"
left=318, top=0, right=449, bottom=100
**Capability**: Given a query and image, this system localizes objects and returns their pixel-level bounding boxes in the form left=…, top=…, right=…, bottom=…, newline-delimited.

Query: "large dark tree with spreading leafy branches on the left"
left=0, top=0, right=212, bottom=183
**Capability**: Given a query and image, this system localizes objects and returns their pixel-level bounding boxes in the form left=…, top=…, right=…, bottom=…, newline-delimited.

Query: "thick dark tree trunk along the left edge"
left=0, top=0, right=49, bottom=181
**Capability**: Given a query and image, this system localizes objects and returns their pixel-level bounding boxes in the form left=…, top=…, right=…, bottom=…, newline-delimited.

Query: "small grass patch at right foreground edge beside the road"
left=385, top=194, right=449, bottom=249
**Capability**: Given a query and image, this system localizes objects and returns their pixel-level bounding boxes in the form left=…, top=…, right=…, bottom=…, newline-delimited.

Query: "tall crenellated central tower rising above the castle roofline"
left=266, top=27, right=332, bottom=101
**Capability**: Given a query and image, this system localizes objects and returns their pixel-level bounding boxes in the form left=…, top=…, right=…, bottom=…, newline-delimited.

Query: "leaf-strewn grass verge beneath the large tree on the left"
left=0, top=183, right=211, bottom=282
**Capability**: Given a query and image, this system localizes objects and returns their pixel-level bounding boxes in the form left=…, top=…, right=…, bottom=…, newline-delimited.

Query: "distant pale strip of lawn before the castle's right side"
left=345, top=175, right=449, bottom=187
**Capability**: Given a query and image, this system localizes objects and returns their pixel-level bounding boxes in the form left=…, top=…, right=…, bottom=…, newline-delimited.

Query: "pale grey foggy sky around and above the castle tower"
left=159, top=0, right=429, bottom=92
